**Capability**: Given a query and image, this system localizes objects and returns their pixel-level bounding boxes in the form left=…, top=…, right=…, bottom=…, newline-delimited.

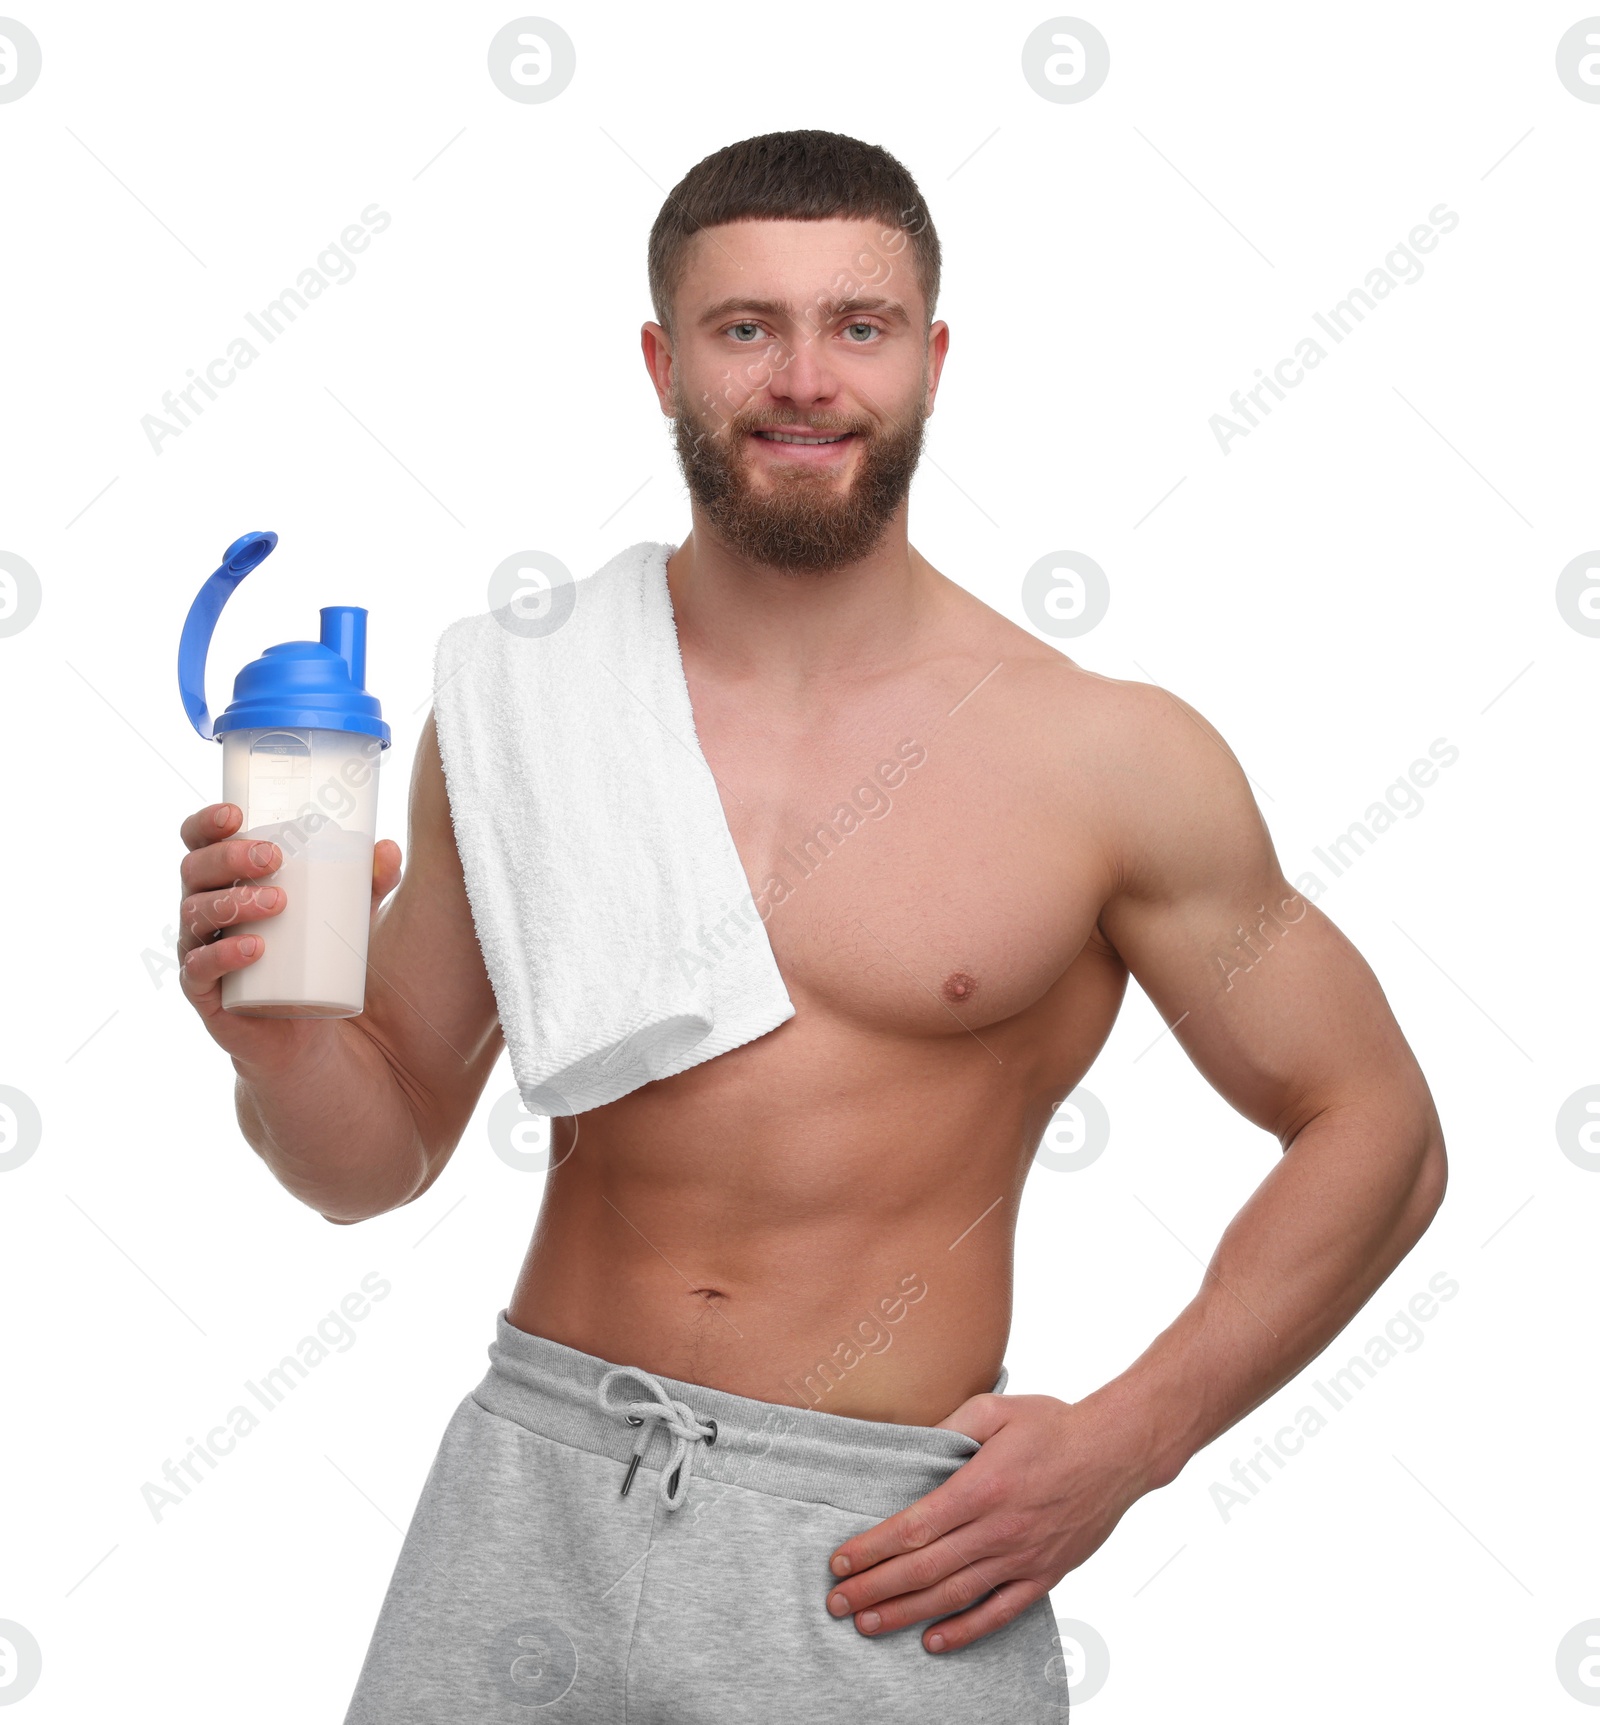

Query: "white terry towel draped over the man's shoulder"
left=433, top=542, right=795, bottom=1114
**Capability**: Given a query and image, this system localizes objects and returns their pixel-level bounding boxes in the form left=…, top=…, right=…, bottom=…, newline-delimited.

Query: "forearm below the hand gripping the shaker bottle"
left=233, top=1018, right=428, bottom=1221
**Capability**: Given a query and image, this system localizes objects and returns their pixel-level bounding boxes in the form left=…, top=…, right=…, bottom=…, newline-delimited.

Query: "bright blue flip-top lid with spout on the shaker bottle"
left=178, top=533, right=390, bottom=749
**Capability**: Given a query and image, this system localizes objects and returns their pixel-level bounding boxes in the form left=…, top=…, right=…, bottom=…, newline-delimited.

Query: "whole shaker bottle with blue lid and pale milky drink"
left=178, top=533, right=390, bottom=1018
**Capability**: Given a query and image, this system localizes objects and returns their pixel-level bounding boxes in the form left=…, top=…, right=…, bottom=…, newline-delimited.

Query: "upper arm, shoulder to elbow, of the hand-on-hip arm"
left=1100, top=690, right=1433, bottom=1145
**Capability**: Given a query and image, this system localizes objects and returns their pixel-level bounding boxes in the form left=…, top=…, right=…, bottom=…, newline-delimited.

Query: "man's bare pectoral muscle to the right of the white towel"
left=700, top=700, right=1105, bottom=1035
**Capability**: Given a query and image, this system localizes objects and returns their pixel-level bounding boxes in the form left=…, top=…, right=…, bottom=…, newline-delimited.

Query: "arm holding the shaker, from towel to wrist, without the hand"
left=234, top=714, right=502, bottom=1221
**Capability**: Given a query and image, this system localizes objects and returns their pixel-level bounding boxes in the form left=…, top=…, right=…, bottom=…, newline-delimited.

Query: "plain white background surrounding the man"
left=0, top=0, right=1600, bottom=1725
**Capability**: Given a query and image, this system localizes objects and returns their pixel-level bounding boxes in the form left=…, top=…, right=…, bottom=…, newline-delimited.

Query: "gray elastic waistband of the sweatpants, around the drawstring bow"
left=472, top=1311, right=1007, bottom=1518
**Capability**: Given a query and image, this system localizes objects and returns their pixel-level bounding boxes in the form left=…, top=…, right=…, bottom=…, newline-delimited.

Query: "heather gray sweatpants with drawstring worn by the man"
left=345, top=1311, right=1067, bottom=1725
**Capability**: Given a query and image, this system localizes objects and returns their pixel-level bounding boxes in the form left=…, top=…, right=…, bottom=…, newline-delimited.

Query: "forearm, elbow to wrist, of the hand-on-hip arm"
left=1090, top=1107, right=1445, bottom=1487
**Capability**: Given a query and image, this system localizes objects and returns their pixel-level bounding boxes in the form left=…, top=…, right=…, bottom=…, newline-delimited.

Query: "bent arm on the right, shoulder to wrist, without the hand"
left=1098, top=690, right=1445, bottom=1485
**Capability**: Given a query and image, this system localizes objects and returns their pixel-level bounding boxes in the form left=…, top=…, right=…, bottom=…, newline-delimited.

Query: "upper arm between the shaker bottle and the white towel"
left=362, top=712, right=503, bottom=1190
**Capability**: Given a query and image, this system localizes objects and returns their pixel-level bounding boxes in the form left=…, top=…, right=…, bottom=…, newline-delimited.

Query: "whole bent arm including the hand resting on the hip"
left=828, top=685, right=1445, bottom=1653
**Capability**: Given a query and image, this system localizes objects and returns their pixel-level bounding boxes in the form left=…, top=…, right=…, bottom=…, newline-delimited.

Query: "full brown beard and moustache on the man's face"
left=672, top=376, right=928, bottom=573
